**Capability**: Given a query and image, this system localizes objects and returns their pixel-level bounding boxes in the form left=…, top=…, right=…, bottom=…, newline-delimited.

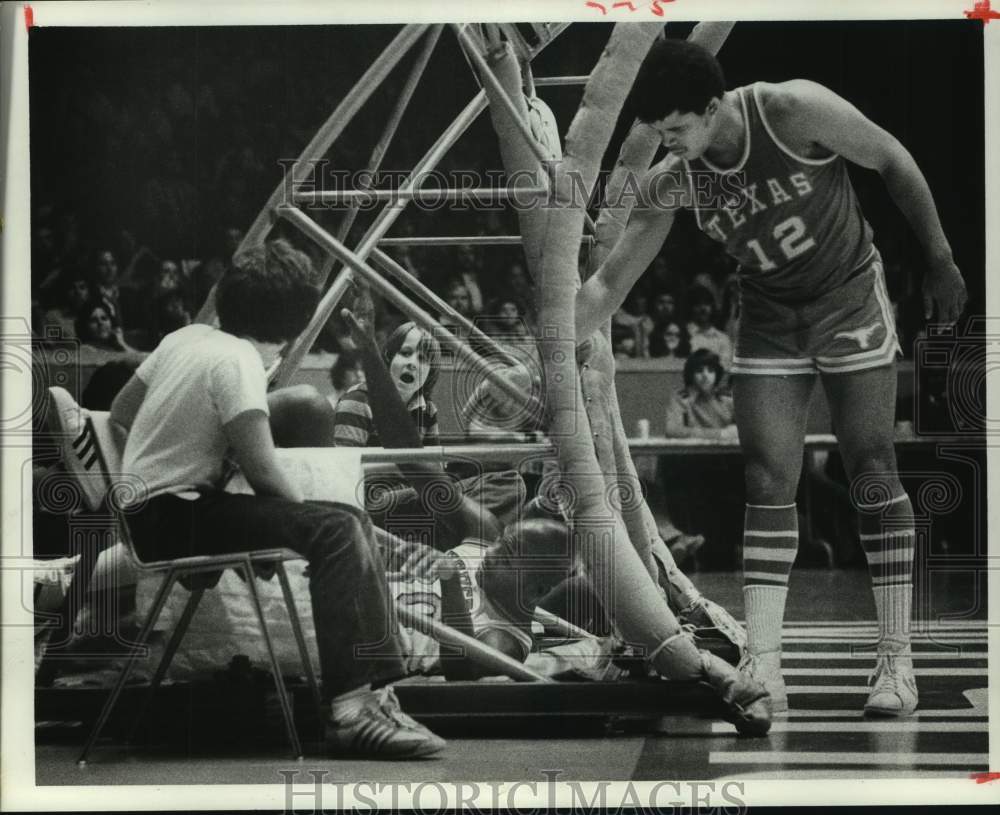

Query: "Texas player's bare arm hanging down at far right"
left=768, top=80, right=966, bottom=323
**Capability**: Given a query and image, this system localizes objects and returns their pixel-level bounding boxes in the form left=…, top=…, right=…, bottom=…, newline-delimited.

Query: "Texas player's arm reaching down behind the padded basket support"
left=576, top=157, right=685, bottom=342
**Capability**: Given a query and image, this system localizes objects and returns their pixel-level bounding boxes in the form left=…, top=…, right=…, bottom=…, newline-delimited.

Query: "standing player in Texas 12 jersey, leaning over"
left=576, top=39, right=966, bottom=716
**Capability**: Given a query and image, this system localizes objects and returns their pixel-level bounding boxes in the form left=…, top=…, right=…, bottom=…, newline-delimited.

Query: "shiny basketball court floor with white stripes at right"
left=35, top=570, right=989, bottom=786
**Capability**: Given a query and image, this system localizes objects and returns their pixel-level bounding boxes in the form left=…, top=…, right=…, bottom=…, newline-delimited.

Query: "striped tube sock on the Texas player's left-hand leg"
left=743, top=504, right=799, bottom=654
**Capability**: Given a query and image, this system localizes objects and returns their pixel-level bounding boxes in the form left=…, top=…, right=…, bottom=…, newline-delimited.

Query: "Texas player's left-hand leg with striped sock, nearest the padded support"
left=733, top=373, right=816, bottom=714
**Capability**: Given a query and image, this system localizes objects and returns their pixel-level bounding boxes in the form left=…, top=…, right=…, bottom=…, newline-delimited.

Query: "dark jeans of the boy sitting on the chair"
left=127, top=492, right=404, bottom=699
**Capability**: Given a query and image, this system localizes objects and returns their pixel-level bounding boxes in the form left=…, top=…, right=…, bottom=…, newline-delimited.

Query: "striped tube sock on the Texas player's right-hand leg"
left=858, top=492, right=914, bottom=650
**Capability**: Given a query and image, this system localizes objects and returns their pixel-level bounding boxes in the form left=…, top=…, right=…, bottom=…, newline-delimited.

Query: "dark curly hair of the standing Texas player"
left=627, top=37, right=726, bottom=122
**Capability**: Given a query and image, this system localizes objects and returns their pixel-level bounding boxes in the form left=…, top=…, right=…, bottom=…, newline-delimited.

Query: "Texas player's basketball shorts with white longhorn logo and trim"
left=732, top=252, right=902, bottom=376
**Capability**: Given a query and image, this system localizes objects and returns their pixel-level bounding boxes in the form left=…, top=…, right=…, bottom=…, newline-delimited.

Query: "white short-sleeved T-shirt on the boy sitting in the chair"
left=123, top=324, right=268, bottom=499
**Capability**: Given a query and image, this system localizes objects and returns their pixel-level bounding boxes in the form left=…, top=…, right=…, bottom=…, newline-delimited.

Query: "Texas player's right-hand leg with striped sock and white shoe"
left=823, top=364, right=917, bottom=716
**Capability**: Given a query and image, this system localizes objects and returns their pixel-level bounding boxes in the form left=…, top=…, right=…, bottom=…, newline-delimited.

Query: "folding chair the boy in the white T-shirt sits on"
left=49, top=387, right=322, bottom=766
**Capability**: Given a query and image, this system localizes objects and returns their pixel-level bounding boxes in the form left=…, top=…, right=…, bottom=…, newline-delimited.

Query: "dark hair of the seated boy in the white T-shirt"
left=215, top=239, right=320, bottom=342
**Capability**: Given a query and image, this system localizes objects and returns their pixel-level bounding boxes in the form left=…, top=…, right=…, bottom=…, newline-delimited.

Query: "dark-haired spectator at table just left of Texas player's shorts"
left=666, top=348, right=736, bottom=439
